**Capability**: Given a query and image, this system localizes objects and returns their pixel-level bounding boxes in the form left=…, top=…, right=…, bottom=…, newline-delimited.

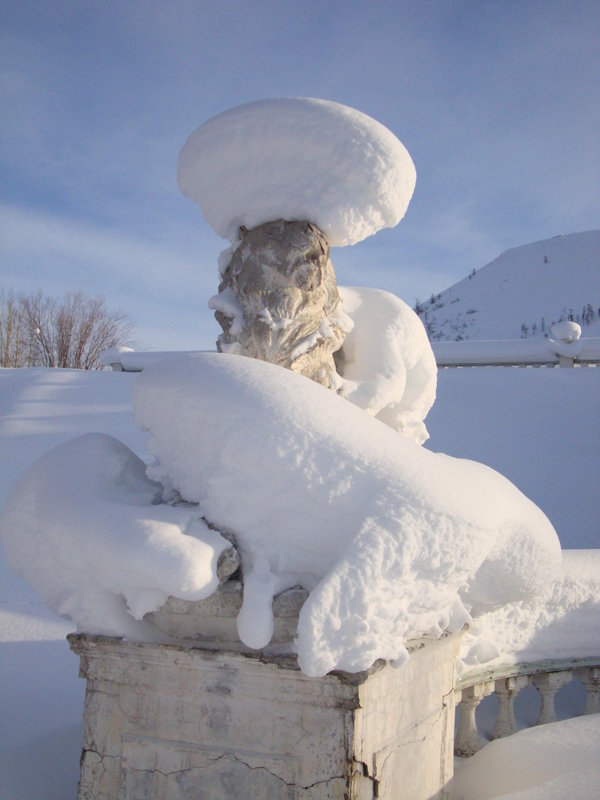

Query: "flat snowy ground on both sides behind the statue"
left=0, top=368, right=600, bottom=800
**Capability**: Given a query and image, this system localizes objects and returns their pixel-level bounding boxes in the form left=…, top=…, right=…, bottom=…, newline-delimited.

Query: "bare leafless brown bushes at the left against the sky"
left=0, top=289, right=133, bottom=369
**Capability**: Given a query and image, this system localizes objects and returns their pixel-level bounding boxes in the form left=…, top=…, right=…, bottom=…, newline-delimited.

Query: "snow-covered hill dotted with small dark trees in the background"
left=416, top=231, right=600, bottom=340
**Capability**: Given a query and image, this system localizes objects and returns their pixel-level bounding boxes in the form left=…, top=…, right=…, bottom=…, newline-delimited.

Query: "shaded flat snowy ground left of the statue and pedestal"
left=0, top=369, right=143, bottom=800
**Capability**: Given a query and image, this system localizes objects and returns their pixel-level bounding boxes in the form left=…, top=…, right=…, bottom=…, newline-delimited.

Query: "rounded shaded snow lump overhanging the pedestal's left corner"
left=0, top=433, right=230, bottom=638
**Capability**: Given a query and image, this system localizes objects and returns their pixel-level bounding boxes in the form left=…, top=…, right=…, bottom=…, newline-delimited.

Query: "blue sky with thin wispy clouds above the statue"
left=0, top=0, right=600, bottom=349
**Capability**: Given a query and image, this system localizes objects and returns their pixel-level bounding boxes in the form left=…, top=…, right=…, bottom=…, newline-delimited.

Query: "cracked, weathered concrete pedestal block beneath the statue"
left=69, top=634, right=458, bottom=800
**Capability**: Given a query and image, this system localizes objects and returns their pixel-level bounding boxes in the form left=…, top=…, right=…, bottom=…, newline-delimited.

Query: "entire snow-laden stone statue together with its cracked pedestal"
left=0, top=98, right=562, bottom=800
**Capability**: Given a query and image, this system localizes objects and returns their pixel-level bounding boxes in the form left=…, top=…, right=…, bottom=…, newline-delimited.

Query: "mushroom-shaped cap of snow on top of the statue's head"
left=177, top=97, right=416, bottom=246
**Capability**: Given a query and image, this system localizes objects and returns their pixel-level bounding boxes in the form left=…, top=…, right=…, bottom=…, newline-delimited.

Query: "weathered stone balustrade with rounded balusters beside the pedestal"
left=454, top=656, right=600, bottom=756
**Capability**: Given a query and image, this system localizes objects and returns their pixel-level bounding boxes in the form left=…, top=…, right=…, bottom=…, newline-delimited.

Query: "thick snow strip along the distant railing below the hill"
left=431, top=337, right=600, bottom=367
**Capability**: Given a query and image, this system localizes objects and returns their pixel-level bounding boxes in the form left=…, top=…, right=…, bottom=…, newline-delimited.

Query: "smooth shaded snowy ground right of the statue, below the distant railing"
left=425, top=367, right=600, bottom=549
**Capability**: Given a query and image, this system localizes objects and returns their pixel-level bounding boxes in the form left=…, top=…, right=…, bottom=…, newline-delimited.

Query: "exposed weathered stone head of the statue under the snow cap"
left=210, top=219, right=352, bottom=389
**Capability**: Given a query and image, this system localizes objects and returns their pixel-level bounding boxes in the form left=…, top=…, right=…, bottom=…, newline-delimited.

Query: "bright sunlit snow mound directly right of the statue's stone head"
left=334, top=286, right=437, bottom=444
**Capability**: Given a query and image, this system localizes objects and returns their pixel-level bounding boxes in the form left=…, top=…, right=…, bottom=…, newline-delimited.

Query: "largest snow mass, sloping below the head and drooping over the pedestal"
left=133, top=353, right=561, bottom=675
